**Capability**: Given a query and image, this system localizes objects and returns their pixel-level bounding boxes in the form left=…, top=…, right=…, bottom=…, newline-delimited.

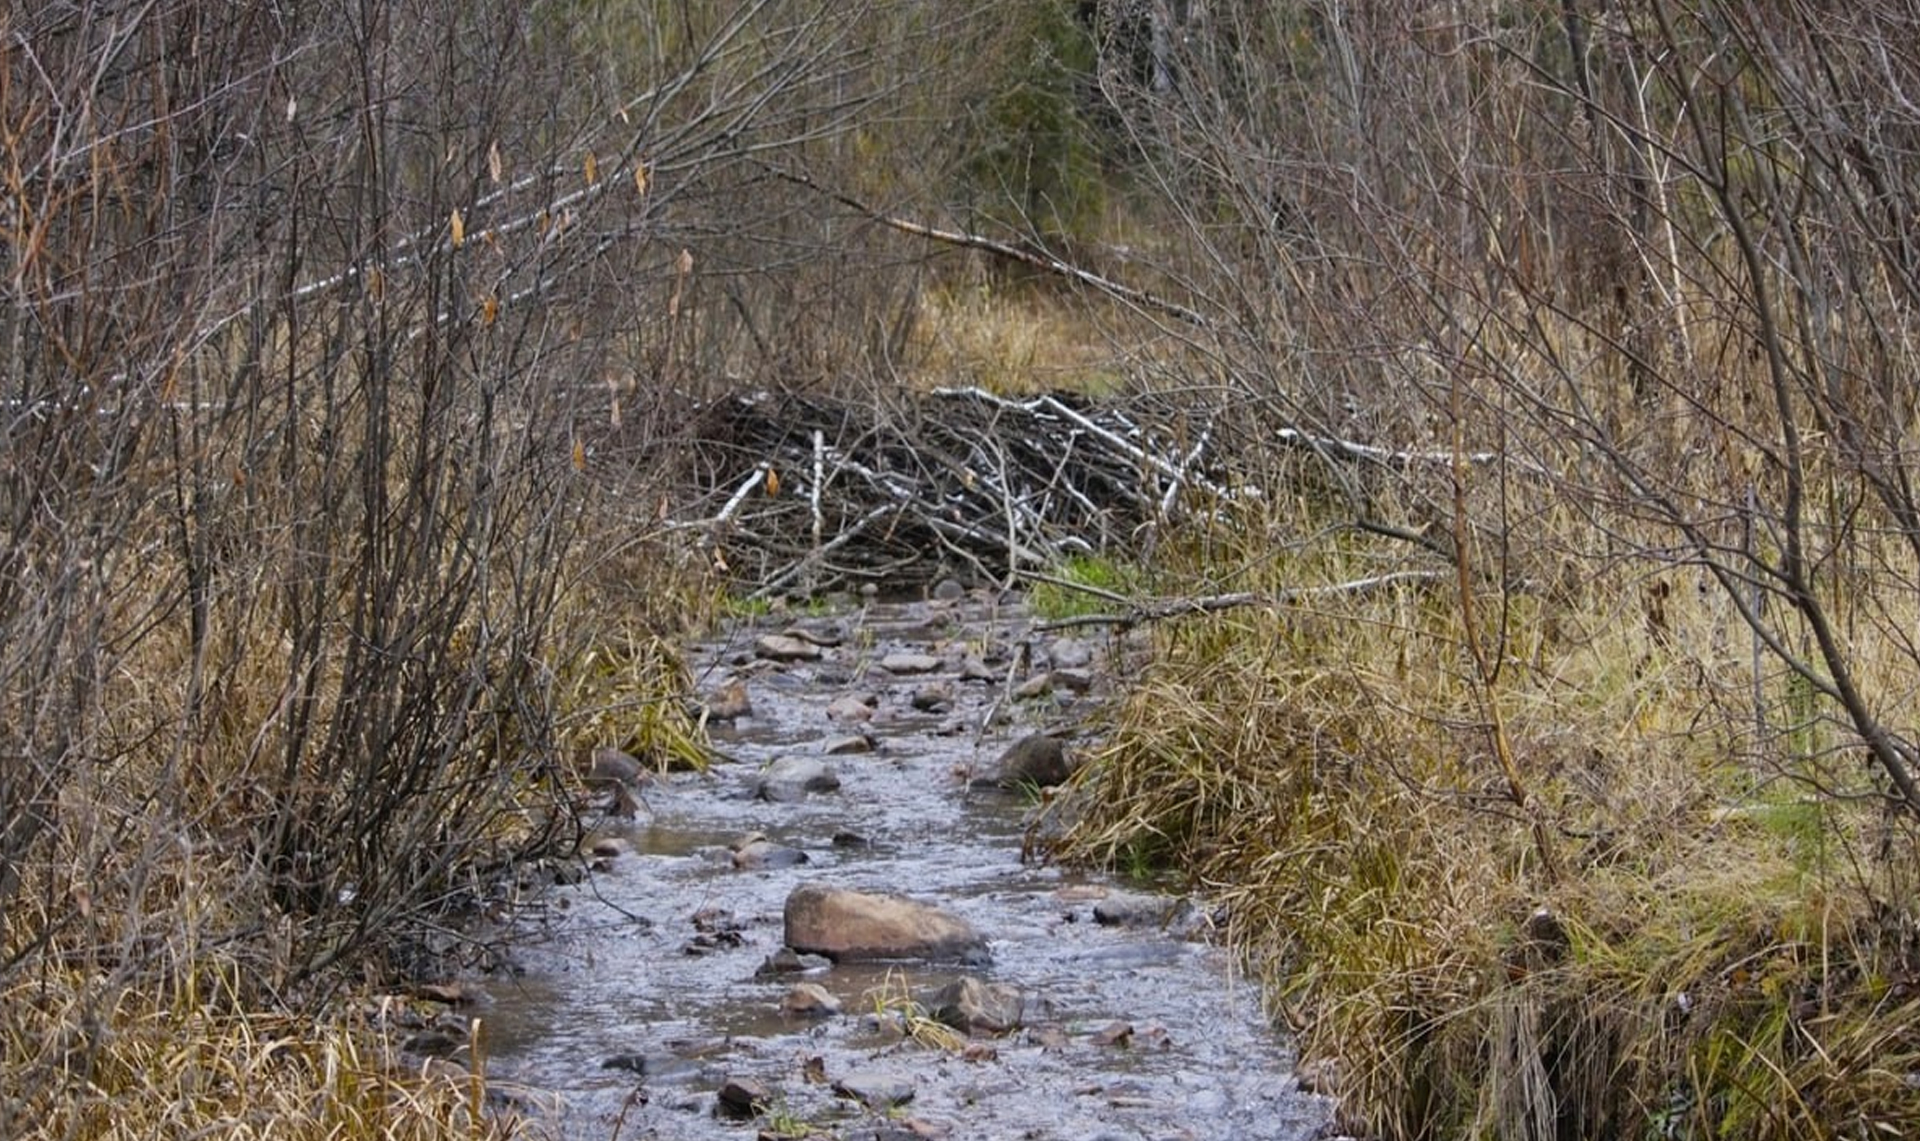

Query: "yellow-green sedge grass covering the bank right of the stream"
left=1066, top=491, right=1920, bottom=1139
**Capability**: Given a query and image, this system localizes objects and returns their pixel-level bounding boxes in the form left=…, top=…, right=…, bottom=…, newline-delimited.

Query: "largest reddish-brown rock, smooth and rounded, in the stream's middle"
left=785, top=884, right=989, bottom=962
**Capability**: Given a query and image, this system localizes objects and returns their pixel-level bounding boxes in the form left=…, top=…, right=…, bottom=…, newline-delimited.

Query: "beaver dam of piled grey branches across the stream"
left=680, top=388, right=1231, bottom=594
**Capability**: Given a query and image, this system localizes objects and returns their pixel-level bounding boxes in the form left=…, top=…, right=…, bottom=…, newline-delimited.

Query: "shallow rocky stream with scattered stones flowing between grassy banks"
left=478, top=588, right=1329, bottom=1141
